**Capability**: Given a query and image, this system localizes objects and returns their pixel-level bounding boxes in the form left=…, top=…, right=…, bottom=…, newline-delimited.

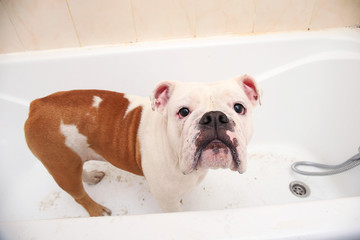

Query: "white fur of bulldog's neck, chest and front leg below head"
left=139, top=106, right=207, bottom=212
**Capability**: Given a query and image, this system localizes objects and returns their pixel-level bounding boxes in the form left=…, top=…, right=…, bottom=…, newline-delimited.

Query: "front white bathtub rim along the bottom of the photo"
left=0, top=197, right=360, bottom=239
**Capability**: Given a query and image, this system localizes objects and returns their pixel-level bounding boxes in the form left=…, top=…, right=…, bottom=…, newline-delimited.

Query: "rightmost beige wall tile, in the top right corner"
left=310, top=0, right=360, bottom=29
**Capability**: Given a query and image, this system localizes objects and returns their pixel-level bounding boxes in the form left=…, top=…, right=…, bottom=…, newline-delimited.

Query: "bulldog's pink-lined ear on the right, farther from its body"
left=236, top=75, right=262, bottom=106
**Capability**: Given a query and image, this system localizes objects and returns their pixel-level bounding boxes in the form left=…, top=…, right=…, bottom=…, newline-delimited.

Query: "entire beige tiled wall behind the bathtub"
left=0, top=0, right=360, bottom=53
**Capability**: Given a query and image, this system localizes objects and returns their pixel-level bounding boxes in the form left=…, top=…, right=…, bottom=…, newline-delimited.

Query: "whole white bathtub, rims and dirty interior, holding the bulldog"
left=0, top=29, right=360, bottom=239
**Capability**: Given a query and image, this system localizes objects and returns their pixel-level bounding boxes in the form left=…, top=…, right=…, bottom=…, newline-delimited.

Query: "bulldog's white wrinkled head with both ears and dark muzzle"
left=152, top=76, right=260, bottom=174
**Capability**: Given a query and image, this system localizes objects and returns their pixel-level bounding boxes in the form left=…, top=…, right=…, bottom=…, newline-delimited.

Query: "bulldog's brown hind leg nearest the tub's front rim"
left=25, top=120, right=111, bottom=216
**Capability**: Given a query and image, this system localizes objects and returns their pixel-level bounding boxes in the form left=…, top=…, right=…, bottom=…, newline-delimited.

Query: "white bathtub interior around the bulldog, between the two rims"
left=0, top=29, right=360, bottom=221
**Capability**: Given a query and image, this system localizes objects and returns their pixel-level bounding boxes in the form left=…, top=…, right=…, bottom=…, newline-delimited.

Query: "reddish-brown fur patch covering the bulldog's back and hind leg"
left=25, top=90, right=143, bottom=216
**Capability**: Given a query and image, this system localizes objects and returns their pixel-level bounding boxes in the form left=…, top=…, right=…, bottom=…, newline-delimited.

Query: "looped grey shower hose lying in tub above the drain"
left=291, top=147, right=360, bottom=176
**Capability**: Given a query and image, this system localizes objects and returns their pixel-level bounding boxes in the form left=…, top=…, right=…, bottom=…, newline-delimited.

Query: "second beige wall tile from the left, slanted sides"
left=3, top=0, right=79, bottom=50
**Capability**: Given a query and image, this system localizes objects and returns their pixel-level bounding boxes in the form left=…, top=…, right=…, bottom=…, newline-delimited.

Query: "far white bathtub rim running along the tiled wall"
left=0, top=27, right=360, bottom=64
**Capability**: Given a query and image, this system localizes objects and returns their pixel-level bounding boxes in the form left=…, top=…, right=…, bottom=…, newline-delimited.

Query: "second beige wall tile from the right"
left=254, top=0, right=315, bottom=33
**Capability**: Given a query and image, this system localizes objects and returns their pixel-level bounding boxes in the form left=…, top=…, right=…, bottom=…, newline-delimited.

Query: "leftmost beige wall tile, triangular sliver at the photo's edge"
left=0, top=1, right=25, bottom=54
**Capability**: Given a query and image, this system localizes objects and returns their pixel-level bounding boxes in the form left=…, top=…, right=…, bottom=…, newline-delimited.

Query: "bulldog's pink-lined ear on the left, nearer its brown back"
left=150, top=81, right=176, bottom=113
